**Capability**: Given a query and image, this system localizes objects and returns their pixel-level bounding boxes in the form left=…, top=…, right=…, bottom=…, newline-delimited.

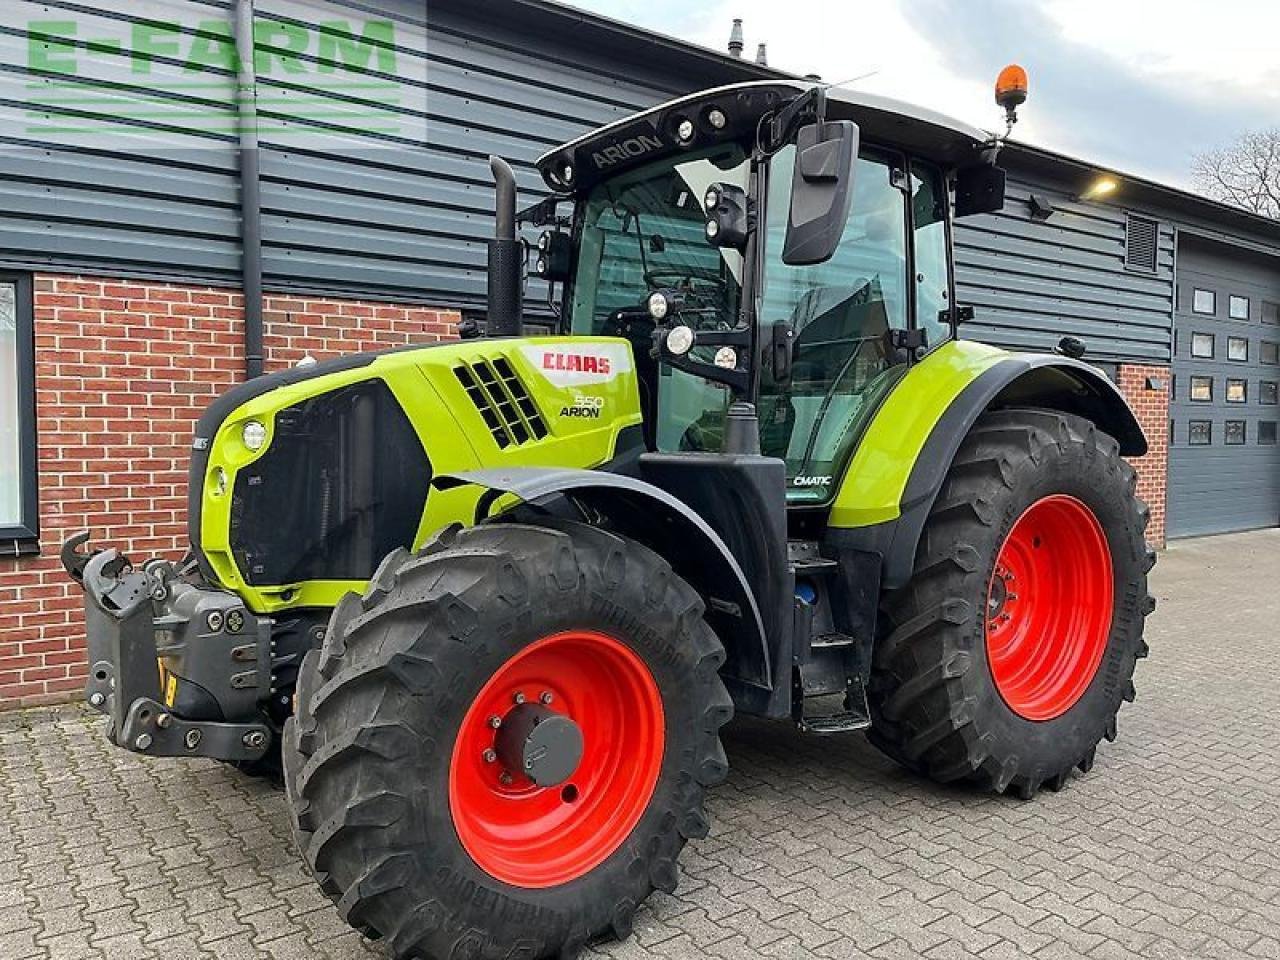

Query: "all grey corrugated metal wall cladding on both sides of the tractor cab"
left=0, top=0, right=1218, bottom=361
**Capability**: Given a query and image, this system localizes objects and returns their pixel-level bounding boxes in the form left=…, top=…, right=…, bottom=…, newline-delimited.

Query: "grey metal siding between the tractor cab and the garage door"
left=955, top=169, right=1174, bottom=362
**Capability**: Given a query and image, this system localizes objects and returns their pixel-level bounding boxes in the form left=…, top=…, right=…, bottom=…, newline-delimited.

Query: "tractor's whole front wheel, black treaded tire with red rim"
left=284, top=521, right=732, bottom=960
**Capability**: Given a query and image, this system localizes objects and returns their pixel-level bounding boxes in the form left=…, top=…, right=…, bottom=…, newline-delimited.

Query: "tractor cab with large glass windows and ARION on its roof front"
left=534, top=83, right=1002, bottom=506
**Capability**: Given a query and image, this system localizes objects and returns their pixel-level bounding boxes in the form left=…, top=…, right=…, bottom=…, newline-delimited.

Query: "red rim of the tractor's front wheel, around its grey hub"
left=449, top=630, right=666, bottom=888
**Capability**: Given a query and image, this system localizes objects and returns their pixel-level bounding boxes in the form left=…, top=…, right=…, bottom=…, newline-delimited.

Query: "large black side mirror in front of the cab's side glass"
left=782, top=120, right=859, bottom=266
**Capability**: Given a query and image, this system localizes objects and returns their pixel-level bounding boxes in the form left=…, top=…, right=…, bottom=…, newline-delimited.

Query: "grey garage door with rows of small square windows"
left=1169, top=237, right=1280, bottom=536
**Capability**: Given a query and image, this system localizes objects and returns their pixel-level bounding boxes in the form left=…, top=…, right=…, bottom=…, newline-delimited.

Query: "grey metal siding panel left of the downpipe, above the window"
left=0, top=0, right=239, bottom=280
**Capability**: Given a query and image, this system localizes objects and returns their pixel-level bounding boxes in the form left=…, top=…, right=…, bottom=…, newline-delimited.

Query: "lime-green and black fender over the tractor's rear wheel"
left=829, top=340, right=1147, bottom=589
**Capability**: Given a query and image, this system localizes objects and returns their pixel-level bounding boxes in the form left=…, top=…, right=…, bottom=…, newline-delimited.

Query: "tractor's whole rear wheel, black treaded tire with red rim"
left=869, top=410, right=1155, bottom=799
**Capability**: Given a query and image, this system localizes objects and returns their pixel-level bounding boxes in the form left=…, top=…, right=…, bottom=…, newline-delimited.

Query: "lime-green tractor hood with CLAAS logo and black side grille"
left=188, top=337, right=641, bottom=613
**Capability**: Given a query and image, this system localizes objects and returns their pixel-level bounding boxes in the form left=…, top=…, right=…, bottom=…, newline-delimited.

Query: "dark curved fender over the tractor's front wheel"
left=433, top=467, right=773, bottom=691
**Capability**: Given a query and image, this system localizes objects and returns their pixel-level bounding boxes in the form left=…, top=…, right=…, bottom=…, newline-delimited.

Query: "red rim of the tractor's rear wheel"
left=986, top=494, right=1114, bottom=721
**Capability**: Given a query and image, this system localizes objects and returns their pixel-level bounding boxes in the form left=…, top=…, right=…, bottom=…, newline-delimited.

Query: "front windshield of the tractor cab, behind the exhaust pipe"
left=568, top=143, right=750, bottom=452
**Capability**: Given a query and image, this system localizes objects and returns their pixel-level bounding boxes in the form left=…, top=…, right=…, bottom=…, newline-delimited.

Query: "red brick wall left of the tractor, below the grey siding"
left=0, top=275, right=457, bottom=708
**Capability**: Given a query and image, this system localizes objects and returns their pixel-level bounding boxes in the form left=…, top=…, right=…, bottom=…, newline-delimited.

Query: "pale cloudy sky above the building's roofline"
left=560, top=0, right=1280, bottom=187
